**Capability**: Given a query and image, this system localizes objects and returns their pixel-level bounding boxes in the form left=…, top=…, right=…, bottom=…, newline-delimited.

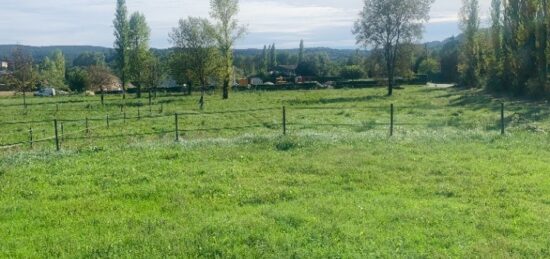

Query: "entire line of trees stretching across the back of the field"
left=2, top=0, right=550, bottom=101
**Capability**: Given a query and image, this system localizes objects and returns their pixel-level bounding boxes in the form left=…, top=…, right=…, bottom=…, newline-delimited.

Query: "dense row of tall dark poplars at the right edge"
left=459, top=0, right=550, bottom=97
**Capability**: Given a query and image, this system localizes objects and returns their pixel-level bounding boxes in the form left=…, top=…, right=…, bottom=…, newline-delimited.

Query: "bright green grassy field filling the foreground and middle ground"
left=0, top=87, right=550, bottom=258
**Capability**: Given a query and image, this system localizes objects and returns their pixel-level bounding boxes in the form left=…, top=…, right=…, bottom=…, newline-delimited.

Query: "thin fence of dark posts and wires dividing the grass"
left=0, top=103, right=516, bottom=151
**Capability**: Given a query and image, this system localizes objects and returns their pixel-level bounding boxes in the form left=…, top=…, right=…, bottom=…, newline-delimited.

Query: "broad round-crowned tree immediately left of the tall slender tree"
left=170, top=17, right=218, bottom=109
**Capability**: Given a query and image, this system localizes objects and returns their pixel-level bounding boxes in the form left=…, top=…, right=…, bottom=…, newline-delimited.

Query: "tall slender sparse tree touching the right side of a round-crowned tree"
left=210, top=0, right=246, bottom=99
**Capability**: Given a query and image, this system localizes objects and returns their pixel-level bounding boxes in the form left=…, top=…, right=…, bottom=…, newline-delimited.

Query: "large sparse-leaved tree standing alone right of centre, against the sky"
left=353, top=0, right=434, bottom=96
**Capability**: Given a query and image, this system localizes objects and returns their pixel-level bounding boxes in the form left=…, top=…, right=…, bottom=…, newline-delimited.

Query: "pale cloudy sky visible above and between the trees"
left=0, top=0, right=490, bottom=48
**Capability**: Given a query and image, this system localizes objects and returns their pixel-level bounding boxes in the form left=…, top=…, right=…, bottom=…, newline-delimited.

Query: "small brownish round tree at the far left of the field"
left=11, top=47, right=38, bottom=108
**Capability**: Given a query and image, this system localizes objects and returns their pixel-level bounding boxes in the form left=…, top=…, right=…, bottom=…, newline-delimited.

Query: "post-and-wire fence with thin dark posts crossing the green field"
left=0, top=104, right=516, bottom=150
